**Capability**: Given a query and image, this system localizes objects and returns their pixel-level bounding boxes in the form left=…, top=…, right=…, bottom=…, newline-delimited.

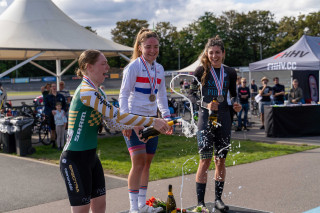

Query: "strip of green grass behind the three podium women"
left=26, top=135, right=319, bottom=180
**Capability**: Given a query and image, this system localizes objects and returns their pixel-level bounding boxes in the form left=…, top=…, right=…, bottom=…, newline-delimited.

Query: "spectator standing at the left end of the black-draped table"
left=259, top=77, right=272, bottom=129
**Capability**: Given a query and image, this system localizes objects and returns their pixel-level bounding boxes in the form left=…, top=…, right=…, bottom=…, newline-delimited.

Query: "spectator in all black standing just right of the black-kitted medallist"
left=236, top=78, right=250, bottom=131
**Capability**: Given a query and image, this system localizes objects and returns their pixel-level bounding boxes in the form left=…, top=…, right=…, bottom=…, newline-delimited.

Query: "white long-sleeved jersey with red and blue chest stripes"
left=119, top=57, right=170, bottom=118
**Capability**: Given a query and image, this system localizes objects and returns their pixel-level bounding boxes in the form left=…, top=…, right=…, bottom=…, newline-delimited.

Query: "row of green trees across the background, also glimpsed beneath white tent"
left=0, top=10, right=320, bottom=77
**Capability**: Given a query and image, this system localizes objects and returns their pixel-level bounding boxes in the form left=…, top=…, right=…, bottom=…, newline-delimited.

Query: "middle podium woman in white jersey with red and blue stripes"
left=119, top=28, right=172, bottom=212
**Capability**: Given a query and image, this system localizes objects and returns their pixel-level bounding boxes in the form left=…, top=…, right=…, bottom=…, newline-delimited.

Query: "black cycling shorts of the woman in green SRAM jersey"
left=60, top=149, right=106, bottom=206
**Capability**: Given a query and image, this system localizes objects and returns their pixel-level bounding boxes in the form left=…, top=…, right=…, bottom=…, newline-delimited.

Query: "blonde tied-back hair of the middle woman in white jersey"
left=130, top=27, right=159, bottom=62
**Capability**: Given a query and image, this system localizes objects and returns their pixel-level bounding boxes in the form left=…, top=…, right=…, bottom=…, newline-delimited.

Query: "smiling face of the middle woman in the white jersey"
left=139, top=37, right=159, bottom=64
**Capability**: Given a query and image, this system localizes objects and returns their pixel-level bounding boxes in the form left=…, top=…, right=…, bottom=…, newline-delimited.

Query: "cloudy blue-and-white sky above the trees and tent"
left=0, top=0, right=320, bottom=39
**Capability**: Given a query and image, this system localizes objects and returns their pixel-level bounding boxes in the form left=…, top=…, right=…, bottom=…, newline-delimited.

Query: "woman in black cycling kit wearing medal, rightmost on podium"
left=194, top=36, right=241, bottom=211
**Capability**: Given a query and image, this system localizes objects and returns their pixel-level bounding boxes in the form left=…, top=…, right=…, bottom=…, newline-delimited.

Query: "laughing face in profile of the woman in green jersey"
left=87, top=54, right=110, bottom=86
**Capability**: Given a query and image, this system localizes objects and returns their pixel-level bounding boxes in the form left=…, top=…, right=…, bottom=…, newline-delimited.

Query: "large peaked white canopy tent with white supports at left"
left=0, top=0, right=133, bottom=86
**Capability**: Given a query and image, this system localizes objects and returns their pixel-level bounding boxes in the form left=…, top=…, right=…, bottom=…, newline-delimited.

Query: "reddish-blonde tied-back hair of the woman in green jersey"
left=76, top=50, right=102, bottom=77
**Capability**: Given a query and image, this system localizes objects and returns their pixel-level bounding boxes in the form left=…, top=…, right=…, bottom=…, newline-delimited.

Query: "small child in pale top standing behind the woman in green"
left=52, top=102, right=67, bottom=151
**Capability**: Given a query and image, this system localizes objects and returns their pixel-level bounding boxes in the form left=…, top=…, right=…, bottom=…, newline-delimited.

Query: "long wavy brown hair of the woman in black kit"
left=200, top=35, right=224, bottom=86
